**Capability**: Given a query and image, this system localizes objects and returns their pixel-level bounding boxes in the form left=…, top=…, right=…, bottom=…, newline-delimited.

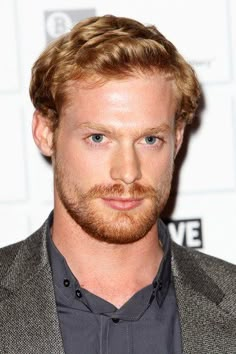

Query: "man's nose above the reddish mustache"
left=110, top=146, right=142, bottom=184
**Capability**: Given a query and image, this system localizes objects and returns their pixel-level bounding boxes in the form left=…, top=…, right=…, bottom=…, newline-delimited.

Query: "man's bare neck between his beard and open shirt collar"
left=52, top=202, right=163, bottom=305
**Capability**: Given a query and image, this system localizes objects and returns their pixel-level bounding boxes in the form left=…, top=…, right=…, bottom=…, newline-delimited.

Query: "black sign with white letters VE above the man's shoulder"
left=164, top=219, right=203, bottom=248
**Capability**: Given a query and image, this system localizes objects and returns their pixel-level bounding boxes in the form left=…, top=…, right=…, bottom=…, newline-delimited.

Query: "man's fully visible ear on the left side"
left=32, top=110, right=53, bottom=156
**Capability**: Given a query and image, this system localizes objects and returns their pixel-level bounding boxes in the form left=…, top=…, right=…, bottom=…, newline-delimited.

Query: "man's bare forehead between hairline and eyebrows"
left=61, top=74, right=176, bottom=128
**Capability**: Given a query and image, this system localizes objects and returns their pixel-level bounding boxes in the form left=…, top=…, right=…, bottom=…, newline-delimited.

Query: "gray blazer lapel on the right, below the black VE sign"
left=172, top=243, right=236, bottom=354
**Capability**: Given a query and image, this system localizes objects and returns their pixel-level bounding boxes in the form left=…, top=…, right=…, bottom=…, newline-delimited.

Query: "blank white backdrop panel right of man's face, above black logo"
left=179, top=86, right=236, bottom=193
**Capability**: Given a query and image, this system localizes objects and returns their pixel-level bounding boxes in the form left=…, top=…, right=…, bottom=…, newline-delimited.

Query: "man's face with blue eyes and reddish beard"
left=53, top=74, right=183, bottom=244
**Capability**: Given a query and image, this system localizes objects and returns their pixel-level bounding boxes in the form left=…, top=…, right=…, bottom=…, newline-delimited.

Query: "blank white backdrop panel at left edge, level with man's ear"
left=0, top=96, right=27, bottom=203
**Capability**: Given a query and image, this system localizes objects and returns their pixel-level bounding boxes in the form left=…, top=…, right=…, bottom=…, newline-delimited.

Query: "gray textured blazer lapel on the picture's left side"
left=0, top=224, right=64, bottom=354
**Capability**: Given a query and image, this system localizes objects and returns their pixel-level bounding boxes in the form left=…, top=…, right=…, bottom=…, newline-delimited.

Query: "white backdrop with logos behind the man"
left=0, top=0, right=236, bottom=263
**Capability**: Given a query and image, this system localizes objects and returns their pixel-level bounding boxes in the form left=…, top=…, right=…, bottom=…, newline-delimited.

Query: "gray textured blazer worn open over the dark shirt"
left=0, top=221, right=236, bottom=354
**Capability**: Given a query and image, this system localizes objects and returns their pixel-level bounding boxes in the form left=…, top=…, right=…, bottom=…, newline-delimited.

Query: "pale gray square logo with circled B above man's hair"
left=44, top=9, right=95, bottom=43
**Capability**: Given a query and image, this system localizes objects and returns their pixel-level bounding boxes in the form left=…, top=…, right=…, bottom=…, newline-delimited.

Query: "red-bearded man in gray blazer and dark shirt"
left=0, top=16, right=236, bottom=354
